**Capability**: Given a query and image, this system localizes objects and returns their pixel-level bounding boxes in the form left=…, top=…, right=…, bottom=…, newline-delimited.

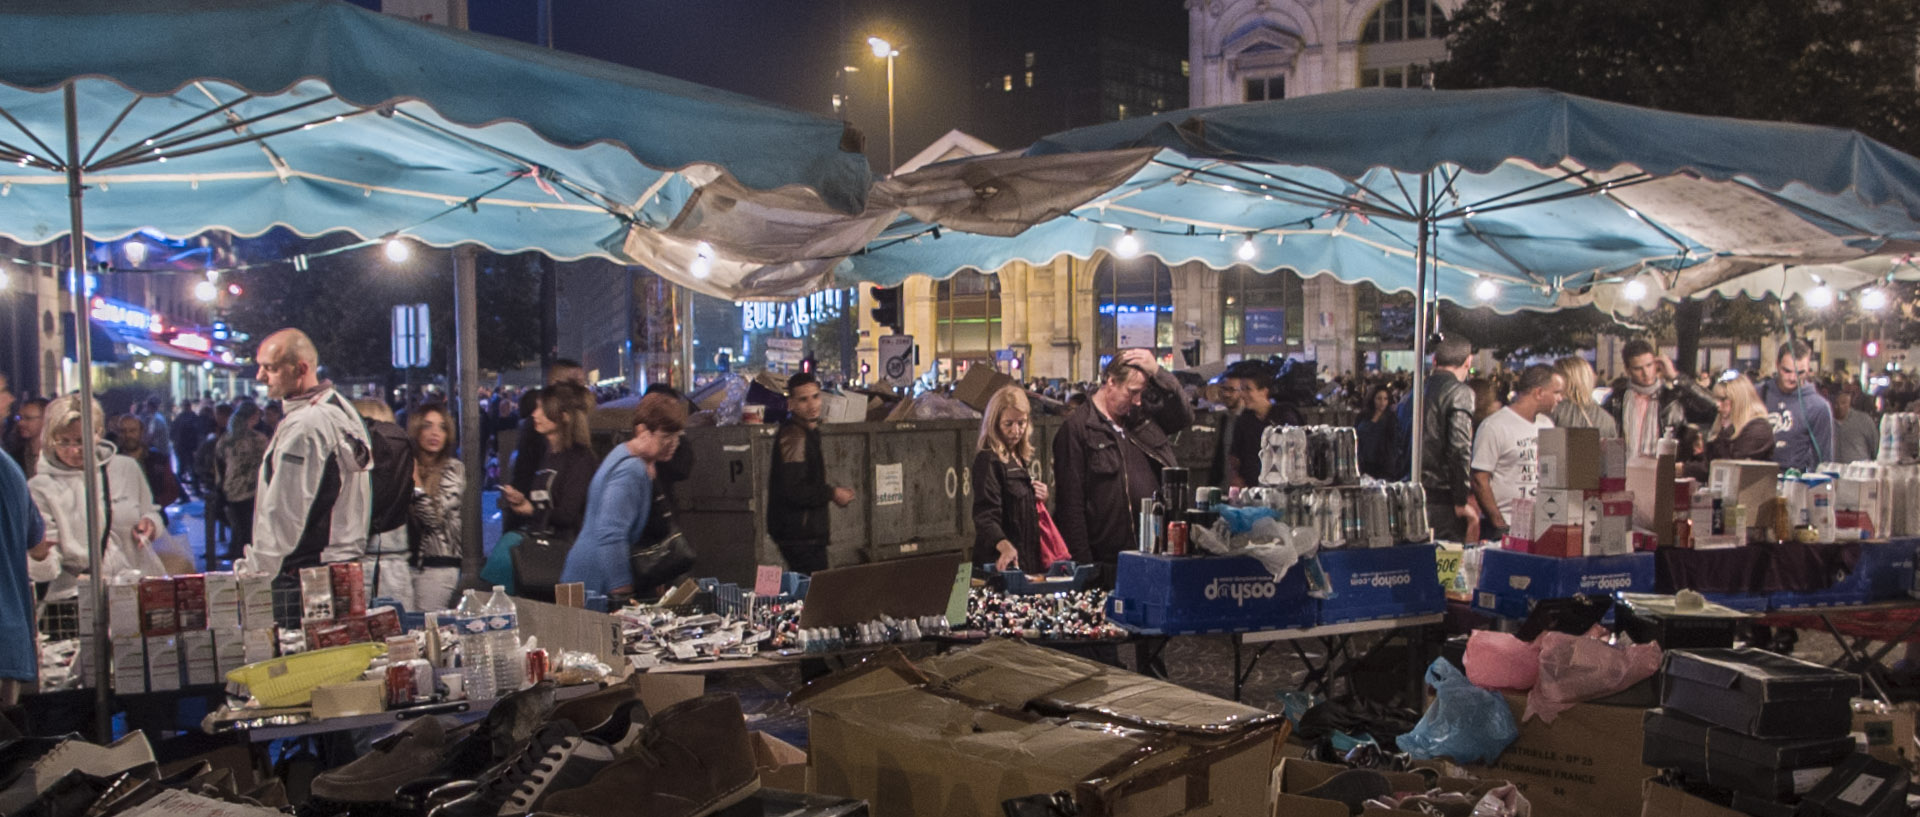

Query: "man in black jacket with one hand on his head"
left=1054, top=349, right=1194, bottom=587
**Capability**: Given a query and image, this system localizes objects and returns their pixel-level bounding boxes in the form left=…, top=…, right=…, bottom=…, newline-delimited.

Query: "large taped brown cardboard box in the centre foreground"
left=793, top=641, right=1286, bottom=817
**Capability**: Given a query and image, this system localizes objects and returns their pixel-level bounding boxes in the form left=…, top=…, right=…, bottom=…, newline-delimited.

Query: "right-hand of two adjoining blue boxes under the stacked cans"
left=1317, top=545, right=1446, bottom=623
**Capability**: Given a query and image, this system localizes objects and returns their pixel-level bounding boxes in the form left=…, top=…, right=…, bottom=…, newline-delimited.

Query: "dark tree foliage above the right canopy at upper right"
left=1434, top=0, right=1920, bottom=153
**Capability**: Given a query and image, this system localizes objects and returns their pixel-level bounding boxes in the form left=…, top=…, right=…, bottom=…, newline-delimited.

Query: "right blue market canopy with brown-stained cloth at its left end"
left=839, top=88, right=1920, bottom=313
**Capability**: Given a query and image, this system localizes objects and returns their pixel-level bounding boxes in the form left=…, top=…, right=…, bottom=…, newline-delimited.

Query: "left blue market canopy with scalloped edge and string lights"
left=0, top=0, right=870, bottom=293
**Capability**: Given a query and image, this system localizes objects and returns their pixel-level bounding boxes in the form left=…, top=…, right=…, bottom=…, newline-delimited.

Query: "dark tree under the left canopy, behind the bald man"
left=228, top=234, right=540, bottom=378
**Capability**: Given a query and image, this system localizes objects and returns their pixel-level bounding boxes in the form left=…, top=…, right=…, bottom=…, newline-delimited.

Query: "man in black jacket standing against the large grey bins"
left=766, top=372, right=854, bottom=573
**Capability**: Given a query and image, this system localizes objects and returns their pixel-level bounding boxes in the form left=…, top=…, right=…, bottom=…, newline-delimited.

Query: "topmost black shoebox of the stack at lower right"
left=1661, top=650, right=1860, bottom=738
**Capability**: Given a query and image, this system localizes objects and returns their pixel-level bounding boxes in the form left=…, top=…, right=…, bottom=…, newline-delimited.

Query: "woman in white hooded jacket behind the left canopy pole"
left=27, top=395, right=167, bottom=598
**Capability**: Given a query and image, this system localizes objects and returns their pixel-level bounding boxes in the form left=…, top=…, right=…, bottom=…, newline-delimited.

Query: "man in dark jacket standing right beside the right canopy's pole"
left=1421, top=338, right=1480, bottom=543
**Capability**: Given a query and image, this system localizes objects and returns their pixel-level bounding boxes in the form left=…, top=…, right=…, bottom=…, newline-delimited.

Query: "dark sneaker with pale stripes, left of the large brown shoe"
left=430, top=713, right=645, bottom=817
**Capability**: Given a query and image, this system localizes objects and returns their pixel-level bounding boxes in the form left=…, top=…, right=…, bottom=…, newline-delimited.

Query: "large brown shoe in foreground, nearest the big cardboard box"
left=543, top=694, right=760, bottom=817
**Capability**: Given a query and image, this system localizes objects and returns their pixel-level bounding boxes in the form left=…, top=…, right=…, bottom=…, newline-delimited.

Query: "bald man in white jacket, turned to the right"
left=234, top=330, right=372, bottom=575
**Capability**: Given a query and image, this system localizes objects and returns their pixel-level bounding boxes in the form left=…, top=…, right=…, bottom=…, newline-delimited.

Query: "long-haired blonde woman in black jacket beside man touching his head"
left=973, top=385, right=1046, bottom=573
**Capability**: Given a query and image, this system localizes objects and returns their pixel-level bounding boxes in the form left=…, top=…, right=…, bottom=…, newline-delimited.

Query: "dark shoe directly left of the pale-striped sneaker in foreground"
left=392, top=681, right=560, bottom=817
